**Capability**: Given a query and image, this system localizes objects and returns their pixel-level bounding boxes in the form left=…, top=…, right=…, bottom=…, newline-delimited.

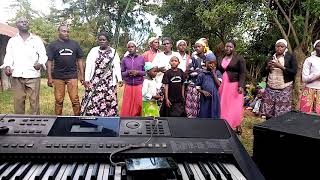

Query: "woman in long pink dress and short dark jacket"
left=218, top=41, right=246, bottom=134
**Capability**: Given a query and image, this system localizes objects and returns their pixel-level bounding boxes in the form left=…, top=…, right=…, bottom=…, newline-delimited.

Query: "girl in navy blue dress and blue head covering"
left=196, top=53, right=221, bottom=118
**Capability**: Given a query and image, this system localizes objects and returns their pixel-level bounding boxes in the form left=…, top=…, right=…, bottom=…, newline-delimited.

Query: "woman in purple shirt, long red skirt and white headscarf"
left=120, top=41, right=146, bottom=116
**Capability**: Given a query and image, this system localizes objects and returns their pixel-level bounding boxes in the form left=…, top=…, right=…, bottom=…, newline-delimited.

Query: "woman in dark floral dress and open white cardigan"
left=81, top=32, right=123, bottom=116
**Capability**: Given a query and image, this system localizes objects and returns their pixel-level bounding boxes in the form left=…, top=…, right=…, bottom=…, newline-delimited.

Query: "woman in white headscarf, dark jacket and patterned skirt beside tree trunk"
left=260, top=39, right=297, bottom=119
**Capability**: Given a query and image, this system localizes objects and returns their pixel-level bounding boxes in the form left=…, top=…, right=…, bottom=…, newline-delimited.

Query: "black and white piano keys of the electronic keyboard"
left=0, top=161, right=246, bottom=180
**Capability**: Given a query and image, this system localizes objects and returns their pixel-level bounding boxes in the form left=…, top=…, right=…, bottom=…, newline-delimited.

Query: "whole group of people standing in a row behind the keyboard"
left=1, top=18, right=320, bottom=135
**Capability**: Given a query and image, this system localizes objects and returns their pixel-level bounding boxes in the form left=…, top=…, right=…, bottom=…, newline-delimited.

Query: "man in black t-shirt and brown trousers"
left=47, top=25, right=84, bottom=116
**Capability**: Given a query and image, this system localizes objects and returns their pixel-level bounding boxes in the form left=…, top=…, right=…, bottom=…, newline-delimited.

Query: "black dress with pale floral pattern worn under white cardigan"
left=81, top=49, right=118, bottom=116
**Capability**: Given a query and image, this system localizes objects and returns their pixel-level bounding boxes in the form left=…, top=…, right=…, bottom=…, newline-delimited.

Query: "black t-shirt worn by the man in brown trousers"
left=47, top=40, right=83, bottom=79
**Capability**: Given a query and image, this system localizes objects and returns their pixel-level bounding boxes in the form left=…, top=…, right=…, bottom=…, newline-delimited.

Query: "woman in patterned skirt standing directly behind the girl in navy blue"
left=186, top=39, right=216, bottom=118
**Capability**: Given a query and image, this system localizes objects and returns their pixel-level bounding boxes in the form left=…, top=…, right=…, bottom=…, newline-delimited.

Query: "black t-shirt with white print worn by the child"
left=162, top=68, right=185, bottom=103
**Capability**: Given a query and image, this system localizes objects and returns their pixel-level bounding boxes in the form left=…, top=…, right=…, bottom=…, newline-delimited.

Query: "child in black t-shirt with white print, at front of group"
left=160, top=56, right=186, bottom=117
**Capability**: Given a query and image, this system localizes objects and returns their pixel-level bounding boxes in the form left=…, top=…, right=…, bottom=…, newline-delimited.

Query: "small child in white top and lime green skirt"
left=142, top=62, right=160, bottom=117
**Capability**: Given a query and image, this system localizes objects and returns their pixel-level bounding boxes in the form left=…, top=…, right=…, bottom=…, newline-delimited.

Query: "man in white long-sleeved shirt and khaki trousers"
left=1, top=17, right=48, bottom=114
